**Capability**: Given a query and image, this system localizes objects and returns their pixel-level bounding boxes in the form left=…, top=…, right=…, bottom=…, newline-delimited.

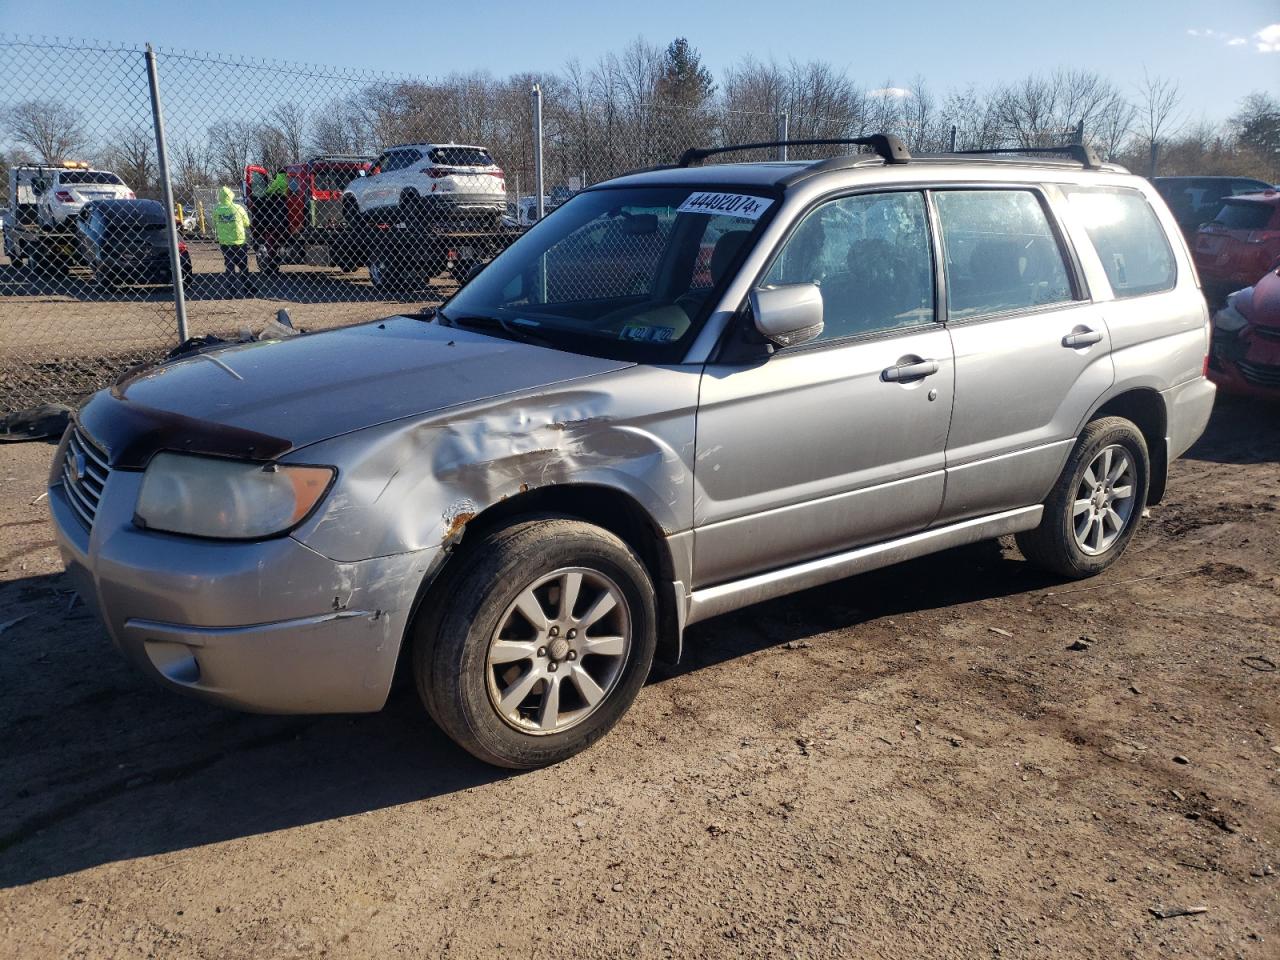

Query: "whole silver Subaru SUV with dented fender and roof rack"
left=49, top=136, right=1213, bottom=768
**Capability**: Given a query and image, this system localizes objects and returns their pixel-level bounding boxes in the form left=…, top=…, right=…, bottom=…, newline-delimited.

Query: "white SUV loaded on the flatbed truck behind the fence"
left=343, top=143, right=507, bottom=223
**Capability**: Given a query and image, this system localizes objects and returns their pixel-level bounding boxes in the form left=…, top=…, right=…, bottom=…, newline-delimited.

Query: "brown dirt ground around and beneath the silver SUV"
left=0, top=402, right=1280, bottom=960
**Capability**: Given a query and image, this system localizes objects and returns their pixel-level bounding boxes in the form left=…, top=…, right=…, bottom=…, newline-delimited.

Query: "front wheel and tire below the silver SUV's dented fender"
left=413, top=520, right=657, bottom=769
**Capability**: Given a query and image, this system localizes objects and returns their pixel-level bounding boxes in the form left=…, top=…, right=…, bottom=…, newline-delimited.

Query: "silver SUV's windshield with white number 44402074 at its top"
left=442, top=187, right=774, bottom=361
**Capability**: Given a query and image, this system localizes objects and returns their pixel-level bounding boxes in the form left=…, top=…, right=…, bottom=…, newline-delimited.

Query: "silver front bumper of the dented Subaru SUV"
left=49, top=451, right=440, bottom=713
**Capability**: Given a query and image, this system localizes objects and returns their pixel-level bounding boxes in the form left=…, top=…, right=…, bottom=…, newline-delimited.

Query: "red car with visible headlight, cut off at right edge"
left=1208, top=269, right=1280, bottom=399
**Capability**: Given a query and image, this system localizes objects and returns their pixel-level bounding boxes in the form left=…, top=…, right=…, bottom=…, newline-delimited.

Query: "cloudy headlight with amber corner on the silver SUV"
left=134, top=453, right=337, bottom=540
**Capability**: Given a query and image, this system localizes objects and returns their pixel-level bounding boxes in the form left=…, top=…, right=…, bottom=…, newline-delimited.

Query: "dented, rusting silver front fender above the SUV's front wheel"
left=284, top=366, right=700, bottom=561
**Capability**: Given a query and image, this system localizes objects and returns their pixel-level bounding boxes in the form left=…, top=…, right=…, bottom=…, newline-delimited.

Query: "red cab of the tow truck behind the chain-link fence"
left=244, top=154, right=372, bottom=273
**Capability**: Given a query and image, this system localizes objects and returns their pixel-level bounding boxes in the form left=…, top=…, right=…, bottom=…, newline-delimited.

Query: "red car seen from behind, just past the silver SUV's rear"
left=1192, top=189, right=1280, bottom=303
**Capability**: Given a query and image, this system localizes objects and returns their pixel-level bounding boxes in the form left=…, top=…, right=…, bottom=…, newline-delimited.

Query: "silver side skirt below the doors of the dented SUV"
left=684, top=504, right=1044, bottom=626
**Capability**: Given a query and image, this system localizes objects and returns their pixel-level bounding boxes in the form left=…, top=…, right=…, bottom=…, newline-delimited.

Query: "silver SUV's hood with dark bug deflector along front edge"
left=78, top=316, right=631, bottom=467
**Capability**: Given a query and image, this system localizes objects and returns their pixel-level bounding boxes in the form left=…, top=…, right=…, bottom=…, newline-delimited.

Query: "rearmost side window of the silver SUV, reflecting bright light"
left=1065, top=187, right=1178, bottom=300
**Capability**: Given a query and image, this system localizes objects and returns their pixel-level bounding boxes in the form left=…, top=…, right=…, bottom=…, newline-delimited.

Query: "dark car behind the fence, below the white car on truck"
left=76, top=200, right=191, bottom=288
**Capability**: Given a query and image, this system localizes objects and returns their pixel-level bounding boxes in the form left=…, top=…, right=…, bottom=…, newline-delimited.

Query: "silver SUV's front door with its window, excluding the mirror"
left=692, top=192, right=954, bottom=588
